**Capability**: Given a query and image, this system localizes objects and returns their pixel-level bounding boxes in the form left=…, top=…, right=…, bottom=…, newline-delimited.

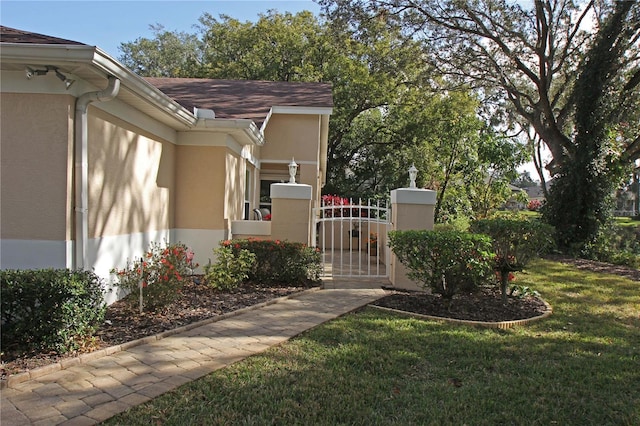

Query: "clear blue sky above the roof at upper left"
left=0, top=0, right=320, bottom=59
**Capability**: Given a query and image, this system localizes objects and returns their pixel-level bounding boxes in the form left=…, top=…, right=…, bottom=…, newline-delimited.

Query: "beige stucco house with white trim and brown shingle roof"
left=0, top=27, right=333, bottom=302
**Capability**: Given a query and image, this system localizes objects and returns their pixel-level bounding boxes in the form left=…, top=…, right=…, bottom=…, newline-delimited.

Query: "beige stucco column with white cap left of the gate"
left=271, top=183, right=313, bottom=244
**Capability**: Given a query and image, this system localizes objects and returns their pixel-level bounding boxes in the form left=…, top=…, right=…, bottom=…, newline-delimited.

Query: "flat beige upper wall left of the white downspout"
left=0, top=93, right=74, bottom=241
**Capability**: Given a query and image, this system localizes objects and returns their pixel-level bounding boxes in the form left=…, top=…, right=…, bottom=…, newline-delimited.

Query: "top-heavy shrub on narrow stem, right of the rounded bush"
left=471, top=217, right=554, bottom=302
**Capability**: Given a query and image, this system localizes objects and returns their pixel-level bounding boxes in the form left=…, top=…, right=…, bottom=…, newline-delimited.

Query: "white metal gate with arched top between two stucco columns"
left=312, top=196, right=391, bottom=278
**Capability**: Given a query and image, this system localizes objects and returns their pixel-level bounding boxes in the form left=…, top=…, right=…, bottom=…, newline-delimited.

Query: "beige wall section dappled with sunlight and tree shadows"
left=88, top=107, right=176, bottom=238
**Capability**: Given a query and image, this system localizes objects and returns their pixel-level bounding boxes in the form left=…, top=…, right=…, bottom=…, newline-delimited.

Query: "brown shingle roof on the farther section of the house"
left=146, top=77, right=333, bottom=127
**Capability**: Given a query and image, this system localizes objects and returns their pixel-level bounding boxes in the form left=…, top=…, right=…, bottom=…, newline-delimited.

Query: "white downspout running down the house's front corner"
left=74, top=76, right=120, bottom=269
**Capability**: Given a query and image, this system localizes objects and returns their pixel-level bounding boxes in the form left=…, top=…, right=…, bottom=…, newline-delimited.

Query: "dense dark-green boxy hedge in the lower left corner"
left=0, top=269, right=106, bottom=353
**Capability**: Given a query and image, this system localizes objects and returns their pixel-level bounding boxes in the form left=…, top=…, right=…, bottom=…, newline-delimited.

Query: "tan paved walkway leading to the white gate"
left=0, top=285, right=385, bottom=426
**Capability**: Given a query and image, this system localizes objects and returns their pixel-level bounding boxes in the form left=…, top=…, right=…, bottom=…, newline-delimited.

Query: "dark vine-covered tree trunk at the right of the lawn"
left=543, top=2, right=640, bottom=251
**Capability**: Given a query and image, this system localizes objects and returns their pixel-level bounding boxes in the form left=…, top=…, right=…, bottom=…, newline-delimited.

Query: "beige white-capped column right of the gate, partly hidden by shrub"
left=389, top=188, right=436, bottom=290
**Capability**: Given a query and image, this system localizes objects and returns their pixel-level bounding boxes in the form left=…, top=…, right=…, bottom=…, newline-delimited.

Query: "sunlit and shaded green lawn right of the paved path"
left=107, top=261, right=640, bottom=425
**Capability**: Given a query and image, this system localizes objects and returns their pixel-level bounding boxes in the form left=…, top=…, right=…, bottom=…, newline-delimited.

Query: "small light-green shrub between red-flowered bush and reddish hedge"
left=204, top=246, right=256, bottom=290
